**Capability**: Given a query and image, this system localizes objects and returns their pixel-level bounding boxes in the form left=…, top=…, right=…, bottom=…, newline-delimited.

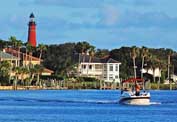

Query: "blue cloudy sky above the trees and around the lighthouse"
left=0, top=0, right=177, bottom=51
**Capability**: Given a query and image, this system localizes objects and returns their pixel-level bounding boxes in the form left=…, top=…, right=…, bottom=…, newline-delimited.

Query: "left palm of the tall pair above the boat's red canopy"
left=130, top=46, right=139, bottom=78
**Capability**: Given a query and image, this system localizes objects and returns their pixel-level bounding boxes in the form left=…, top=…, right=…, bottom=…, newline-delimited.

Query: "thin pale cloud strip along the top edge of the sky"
left=20, top=0, right=154, bottom=8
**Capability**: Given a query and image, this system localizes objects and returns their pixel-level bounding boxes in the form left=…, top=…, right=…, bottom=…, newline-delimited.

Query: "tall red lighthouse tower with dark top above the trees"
left=28, top=13, right=36, bottom=47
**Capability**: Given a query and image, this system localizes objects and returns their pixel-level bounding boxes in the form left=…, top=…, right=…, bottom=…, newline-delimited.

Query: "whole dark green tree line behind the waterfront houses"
left=0, top=37, right=177, bottom=85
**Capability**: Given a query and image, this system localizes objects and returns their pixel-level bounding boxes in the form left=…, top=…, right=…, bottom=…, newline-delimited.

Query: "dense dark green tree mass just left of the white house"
left=43, top=43, right=75, bottom=74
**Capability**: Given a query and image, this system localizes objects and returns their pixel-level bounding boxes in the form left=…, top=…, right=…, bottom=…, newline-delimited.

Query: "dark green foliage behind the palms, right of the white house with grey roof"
left=110, top=47, right=177, bottom=80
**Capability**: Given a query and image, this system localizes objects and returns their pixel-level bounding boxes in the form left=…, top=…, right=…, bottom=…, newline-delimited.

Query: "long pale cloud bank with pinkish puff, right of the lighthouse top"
left=37, top=10, right=177, bottom=30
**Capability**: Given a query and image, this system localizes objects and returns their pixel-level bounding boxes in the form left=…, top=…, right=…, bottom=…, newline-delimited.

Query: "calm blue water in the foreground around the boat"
left=0, top=90, right=177, bottom=122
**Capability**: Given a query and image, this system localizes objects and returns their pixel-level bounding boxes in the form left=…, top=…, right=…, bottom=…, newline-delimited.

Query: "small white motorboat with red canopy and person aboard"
left=119, top=78, right=150, bottom=105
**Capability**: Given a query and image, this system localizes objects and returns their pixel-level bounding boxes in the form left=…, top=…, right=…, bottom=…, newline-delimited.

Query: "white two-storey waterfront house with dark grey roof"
left=78, top=55, right=121, bottom=82
